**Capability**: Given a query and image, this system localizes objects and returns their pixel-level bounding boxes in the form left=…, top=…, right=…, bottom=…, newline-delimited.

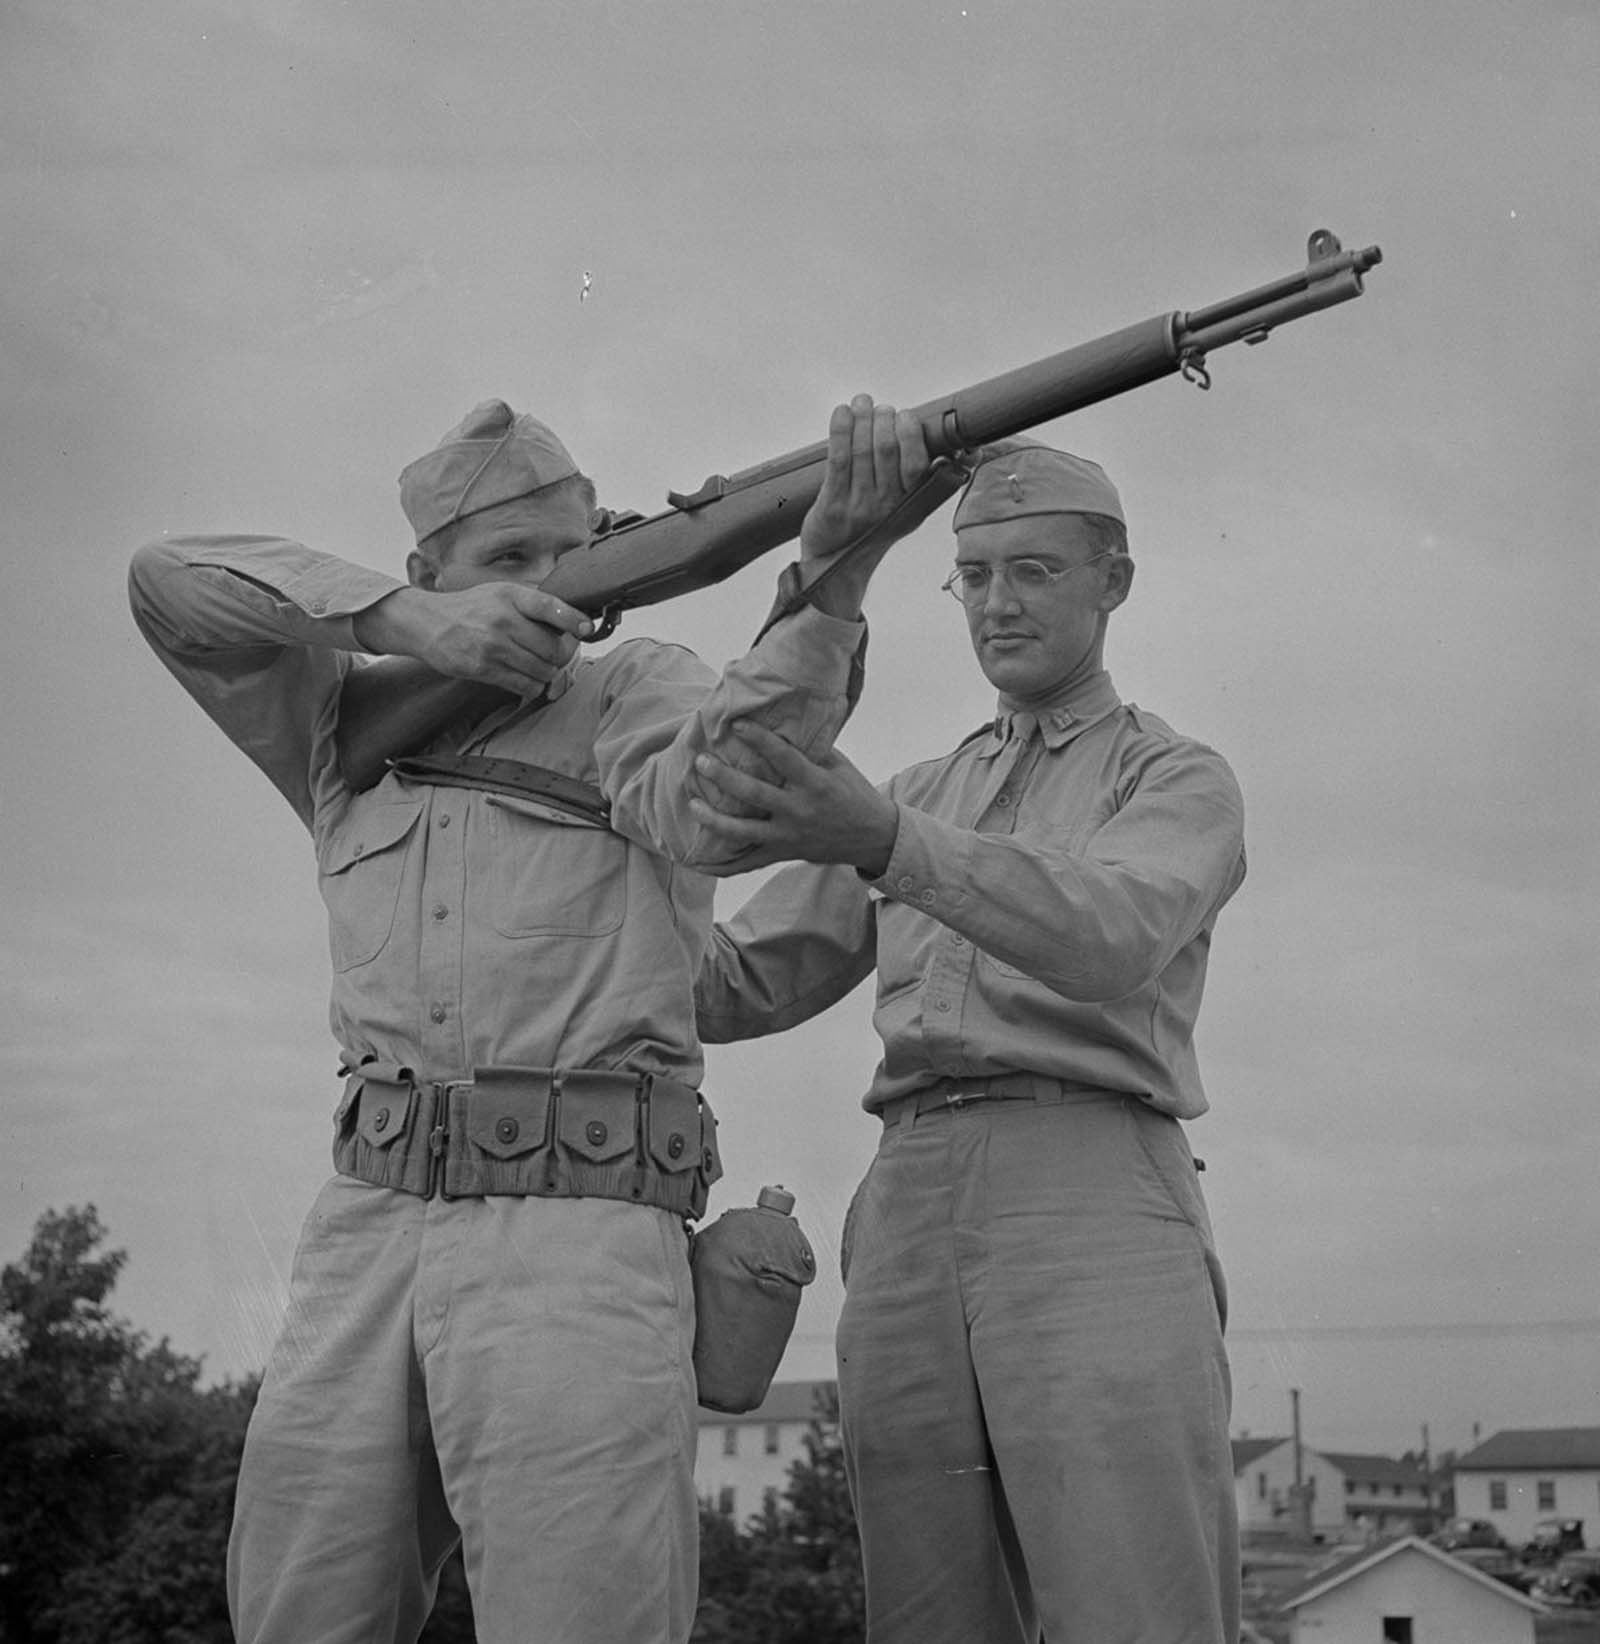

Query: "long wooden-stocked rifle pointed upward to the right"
left=339, top=229, right=1383, bottom=789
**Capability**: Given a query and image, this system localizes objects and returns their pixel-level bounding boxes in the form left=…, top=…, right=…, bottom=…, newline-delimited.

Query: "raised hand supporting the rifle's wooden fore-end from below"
left=801, top=395, right=965, bottom=618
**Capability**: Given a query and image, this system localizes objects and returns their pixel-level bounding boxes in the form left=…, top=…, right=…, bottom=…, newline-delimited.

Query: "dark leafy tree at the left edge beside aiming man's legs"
left=0, top=1205, right=255, bottom=1644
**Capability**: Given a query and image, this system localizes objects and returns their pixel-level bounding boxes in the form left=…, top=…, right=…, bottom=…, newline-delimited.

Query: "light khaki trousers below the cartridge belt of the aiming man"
left=229, top=1177, right=697, bottom=1644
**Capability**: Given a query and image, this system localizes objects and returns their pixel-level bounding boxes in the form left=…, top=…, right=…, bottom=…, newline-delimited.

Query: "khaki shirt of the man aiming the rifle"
left=130, top=538, right=863, bottom=1085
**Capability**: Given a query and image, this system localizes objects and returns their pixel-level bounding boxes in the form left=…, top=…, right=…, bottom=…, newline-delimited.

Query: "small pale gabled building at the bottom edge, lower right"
left=1284, top=1535, right=1544, bottom=1644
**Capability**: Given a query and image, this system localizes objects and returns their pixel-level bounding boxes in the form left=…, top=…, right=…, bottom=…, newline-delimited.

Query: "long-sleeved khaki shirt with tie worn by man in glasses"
left=697, top=672, right=1245, bottom=1118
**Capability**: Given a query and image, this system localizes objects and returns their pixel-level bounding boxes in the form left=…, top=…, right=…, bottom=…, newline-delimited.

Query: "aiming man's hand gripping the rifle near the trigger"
left=355, top=582, right=594, bottom=697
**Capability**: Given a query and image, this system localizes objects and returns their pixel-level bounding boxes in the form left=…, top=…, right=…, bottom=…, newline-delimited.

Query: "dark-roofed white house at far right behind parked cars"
left=1455, top=1427, right=1600, bottom=1547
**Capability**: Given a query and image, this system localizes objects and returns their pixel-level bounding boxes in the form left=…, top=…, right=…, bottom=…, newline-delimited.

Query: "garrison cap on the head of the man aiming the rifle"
left=400, top=399, right=579, bottom=543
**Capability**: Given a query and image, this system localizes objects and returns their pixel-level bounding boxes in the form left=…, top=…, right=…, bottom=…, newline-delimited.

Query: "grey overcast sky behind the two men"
left=0, top=0, right=1600, bottom=1453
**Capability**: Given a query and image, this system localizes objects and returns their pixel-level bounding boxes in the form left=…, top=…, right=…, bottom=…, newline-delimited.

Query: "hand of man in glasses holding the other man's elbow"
left=689, top=720, right=899, bottom=878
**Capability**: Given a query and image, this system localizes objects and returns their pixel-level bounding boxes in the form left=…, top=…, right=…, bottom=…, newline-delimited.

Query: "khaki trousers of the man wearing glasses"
left=839, top=1093, right=1238, bottom=1644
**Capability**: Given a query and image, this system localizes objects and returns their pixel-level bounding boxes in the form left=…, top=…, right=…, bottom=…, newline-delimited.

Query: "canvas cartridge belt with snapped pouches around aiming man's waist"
left=334, top=1062, right=722, bottom=1218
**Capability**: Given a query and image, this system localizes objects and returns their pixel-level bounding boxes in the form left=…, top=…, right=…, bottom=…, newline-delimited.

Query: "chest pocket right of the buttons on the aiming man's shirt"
left=483, top=794, right=628, bottom=937
